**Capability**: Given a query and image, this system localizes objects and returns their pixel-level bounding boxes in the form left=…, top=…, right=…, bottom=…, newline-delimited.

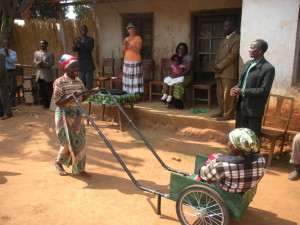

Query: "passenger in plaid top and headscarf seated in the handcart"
left=197, top=128, right=266, bottom=193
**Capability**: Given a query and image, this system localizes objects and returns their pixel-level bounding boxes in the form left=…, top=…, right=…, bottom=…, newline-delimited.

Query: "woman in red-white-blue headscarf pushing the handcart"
left=53, top=54, right=100, bottom=177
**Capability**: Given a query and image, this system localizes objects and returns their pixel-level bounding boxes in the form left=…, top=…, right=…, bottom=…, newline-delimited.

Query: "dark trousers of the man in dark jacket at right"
left=235, top=101, right=262, bottom=138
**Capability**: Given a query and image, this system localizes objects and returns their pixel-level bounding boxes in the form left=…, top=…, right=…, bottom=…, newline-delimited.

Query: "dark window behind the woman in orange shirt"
left=122, top=13, right=153, bottom=59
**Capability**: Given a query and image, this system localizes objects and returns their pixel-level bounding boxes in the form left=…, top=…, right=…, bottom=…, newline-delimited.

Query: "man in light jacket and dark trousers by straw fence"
left=34, top=40, right=55, bottom=109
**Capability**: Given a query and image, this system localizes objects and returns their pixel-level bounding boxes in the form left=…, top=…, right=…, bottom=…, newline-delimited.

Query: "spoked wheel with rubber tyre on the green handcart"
left=176, top=185, right=230, bottom=225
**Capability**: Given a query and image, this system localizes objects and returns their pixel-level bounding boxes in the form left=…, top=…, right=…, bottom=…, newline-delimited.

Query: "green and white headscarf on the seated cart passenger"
left=229, top=128, right=260, bottom=156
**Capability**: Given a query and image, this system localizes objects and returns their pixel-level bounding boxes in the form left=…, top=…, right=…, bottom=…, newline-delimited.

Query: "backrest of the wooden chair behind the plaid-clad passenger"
left=262, top=94, right=294, bottom=132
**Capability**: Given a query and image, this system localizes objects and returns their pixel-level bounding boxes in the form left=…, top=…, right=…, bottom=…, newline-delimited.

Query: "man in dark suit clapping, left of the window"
left=72, top=25, right=95, bottom=90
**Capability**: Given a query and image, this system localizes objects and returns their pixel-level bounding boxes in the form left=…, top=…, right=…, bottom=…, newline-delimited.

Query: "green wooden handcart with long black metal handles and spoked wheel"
left=72, top=89, right=257, bottom=225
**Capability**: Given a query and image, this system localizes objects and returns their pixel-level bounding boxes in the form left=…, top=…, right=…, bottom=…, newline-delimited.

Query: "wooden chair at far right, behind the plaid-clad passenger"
left=261, top=94, right=294, bottom=166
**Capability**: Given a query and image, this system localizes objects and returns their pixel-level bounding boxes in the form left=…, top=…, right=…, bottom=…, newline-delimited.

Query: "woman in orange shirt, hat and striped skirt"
left=122, top=23, right=144, bottom=94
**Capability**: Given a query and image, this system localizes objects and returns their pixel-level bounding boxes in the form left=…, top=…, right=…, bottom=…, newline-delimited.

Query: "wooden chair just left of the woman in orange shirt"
left=94, top=58, right=115, bottom=88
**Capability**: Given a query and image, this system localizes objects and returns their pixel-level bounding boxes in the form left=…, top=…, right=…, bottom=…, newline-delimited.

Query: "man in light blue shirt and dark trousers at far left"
left=0, top=40, right=17, bottom=106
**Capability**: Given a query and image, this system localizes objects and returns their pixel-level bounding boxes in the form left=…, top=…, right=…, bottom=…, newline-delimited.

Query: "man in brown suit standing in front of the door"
left=212, top=20, right=240, bottom=121
